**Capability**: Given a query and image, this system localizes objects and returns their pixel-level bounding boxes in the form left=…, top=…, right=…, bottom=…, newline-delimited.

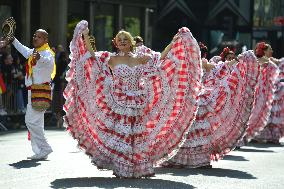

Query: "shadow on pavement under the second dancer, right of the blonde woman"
left=155, top=168, right=256, bottom=179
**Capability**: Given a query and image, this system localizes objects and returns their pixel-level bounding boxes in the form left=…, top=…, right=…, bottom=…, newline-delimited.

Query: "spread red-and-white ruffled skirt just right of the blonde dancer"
left=163, top=46, right=259, bottom=168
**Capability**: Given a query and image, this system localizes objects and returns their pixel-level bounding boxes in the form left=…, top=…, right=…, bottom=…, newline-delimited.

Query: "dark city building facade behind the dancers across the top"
left=0, top=0, right=284, bottom=57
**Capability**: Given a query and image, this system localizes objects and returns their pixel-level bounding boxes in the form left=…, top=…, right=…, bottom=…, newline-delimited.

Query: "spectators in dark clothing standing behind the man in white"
left=0, top=41, right=69, bottom=128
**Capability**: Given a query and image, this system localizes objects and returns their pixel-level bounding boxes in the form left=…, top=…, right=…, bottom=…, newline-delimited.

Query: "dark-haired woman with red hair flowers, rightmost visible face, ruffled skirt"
left=245, top=42, right=279, bottom=143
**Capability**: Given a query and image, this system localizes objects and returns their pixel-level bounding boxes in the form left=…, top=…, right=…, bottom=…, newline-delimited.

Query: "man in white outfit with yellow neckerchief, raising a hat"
left=1, top=22, right=55, bottom=159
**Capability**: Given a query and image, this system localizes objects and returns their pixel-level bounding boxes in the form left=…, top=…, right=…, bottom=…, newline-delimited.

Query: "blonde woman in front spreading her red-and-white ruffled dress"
left=64, top=21, right=201, bottom=178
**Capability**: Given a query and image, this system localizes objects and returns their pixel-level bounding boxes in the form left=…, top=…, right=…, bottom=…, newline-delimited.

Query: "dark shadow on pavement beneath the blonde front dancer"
left=51, top=177, right=195, bottom=189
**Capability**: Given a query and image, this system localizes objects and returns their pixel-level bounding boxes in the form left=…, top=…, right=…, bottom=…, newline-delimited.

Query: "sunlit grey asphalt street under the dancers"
left=0, top=130, right=284, bottom=189
